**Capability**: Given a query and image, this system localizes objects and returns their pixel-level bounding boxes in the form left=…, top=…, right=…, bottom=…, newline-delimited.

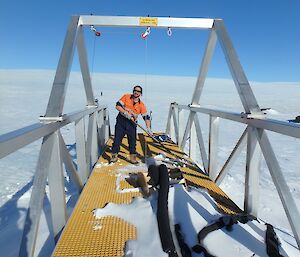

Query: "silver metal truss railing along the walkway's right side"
left=166, top=103, right=300, bottom=248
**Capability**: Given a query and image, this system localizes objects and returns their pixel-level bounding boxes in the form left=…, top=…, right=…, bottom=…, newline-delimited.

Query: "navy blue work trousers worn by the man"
left=112, top=113, right=136, bottom=154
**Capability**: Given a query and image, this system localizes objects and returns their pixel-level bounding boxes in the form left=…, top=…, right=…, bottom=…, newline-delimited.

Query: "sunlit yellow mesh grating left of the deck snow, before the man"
left=53, top=137, right=141, bottom=257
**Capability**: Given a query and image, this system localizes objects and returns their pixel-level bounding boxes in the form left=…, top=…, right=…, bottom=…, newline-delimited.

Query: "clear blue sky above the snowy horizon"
left=0, top=0, right=300, bottom=81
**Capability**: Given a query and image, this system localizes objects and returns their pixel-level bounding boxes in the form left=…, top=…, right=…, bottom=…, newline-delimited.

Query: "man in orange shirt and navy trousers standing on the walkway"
left=111, top=85, right=152, bottom=164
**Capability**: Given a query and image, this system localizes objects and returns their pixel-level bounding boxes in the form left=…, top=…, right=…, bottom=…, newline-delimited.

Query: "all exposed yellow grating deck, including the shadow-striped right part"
left=53, top=134, right=241, bottom=257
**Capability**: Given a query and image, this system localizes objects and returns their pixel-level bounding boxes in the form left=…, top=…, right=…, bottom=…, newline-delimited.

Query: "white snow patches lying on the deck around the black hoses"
left=94, top=180, right=299, bottom=257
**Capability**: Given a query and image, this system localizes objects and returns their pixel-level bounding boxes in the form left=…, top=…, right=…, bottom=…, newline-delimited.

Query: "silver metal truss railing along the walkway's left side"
left=0, top=106, right=110, bottom=256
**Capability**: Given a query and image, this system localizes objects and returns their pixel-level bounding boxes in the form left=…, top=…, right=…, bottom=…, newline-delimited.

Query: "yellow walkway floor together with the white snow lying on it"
left=53, top=135, right=299, bottom=257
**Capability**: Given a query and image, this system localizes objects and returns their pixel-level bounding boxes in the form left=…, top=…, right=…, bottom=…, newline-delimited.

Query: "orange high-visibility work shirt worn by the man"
left=117, top=94, right=148, bottom=119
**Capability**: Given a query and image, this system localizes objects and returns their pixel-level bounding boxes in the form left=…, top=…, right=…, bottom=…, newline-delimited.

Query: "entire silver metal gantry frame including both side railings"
left=0, top=15, right=300, bottom=256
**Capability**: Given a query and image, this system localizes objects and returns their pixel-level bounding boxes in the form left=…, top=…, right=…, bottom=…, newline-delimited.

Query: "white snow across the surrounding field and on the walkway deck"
left=0, top=70, right=300, bottom=257
